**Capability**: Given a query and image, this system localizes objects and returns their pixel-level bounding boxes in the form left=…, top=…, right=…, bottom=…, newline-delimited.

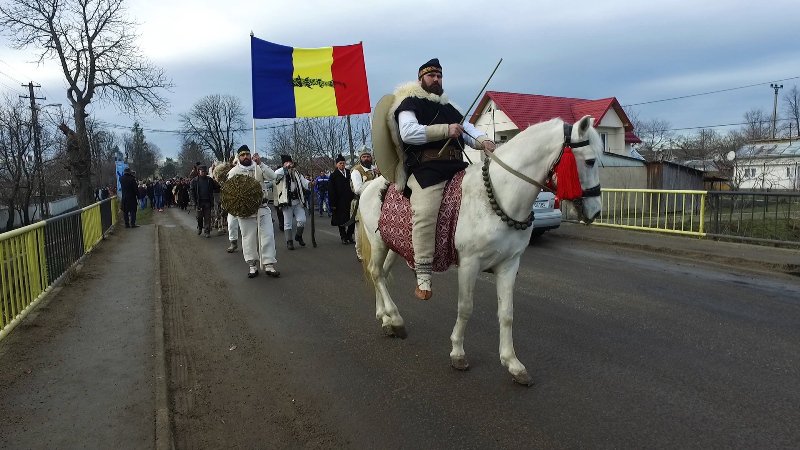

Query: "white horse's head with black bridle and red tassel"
left=553, top=116, right=603, bottom=224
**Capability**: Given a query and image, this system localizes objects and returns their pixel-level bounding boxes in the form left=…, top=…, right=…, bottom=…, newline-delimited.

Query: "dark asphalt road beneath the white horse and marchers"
left=157, top=210, right=800, bottom=448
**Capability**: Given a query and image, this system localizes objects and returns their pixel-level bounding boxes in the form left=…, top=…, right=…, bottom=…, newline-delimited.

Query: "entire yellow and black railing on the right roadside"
left=580, top=189, right=800, bottom=245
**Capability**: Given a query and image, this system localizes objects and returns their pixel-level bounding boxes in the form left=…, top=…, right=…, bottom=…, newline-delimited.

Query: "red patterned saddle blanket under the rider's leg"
left=378, top=170, right=464, bottom=272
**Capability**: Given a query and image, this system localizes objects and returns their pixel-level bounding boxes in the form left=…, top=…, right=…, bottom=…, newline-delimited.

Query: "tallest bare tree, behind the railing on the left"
left=0, top=0, right=171, bottom=205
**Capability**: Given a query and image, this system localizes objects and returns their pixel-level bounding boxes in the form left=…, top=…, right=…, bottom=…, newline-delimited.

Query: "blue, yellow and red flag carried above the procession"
left=250, top=36, right=370, bottom=119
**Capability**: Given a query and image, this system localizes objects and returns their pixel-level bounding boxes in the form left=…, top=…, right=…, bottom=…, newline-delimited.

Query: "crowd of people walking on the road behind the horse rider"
left=118, top=150, right=378, bottom=278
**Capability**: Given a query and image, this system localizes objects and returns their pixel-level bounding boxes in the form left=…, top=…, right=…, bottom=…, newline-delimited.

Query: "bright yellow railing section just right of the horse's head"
left=594, top=189, right=708, bottom=236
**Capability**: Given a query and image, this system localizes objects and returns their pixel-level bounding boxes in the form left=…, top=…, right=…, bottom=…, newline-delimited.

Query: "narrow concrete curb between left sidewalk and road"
left=153, top=224, right=175, bottom=450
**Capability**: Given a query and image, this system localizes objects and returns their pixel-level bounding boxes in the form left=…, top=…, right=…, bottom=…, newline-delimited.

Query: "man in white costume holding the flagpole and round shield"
left=227, top=145, right=281, bottom=278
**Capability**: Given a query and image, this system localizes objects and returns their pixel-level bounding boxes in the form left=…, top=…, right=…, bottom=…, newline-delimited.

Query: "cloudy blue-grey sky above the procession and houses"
left=0, top=0, right=800, bottom=157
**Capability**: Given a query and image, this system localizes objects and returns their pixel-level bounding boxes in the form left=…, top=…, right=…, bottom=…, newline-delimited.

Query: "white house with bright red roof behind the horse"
left=469, top=91, right=641, bottom=156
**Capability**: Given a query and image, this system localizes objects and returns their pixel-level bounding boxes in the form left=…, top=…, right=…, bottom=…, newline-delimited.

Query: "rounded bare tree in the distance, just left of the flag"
left=181, top=94, right=246, bottom=161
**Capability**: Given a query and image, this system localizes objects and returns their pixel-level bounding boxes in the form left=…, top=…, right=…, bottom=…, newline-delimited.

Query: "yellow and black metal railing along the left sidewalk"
left=0, top=197, right=118, bottom=339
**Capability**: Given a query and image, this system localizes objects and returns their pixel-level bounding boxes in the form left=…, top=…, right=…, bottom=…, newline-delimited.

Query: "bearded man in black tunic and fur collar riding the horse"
left=394, top=58, right=495, bottom=300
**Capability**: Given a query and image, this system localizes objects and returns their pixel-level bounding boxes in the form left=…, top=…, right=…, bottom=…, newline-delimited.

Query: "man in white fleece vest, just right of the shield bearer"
left=275, top=155, right=314, bottom=250
